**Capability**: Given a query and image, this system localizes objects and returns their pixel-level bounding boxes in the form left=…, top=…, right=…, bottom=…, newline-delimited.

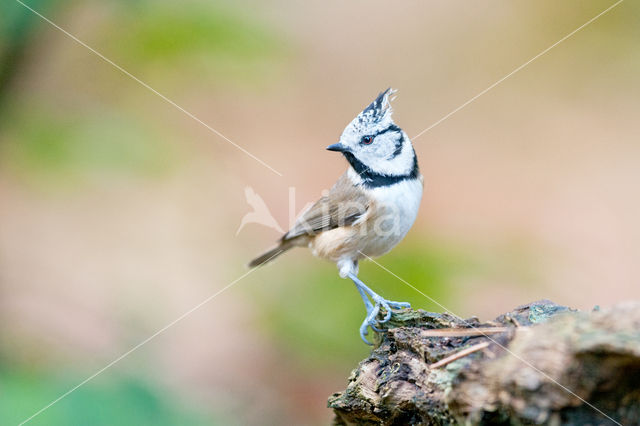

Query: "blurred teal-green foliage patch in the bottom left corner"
left=0, top=367, right=221, bottom=426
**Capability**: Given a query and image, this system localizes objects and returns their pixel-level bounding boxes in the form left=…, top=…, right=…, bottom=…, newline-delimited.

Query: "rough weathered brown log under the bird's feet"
left=329, top=301, right=640, bottom=425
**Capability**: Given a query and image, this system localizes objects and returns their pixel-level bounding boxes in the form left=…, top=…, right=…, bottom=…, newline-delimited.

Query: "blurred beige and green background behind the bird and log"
left=0, top=0, right=640, bottom=425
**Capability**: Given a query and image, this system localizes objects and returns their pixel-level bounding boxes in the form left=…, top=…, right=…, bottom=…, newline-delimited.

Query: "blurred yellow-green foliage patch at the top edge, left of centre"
left=104, top=0, right=288, bottom=87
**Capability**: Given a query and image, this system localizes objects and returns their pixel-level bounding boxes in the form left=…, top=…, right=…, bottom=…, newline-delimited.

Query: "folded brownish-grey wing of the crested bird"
left=282, top=173, right=369, bottom=242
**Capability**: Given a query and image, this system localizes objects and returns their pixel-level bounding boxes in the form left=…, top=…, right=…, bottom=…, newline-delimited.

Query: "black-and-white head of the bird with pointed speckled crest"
left=327, top=88, right=417, bottom=176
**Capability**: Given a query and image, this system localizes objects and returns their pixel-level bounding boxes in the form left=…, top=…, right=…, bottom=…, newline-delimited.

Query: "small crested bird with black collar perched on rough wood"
left=249, top=88, right=424, bottom=345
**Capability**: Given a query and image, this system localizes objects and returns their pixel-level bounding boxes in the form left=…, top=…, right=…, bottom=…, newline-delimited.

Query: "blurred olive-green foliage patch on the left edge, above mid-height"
left=0, top=106, right=179, bottom=184
